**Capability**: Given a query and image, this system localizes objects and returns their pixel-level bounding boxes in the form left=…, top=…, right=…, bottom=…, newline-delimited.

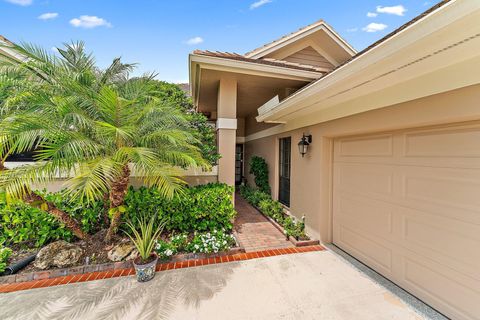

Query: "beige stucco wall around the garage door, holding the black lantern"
left=245, top=85, right=480, bottom=242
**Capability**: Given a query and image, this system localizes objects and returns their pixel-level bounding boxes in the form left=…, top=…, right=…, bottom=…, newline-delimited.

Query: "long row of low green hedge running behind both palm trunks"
left=0, top=183, right=236, bottom=247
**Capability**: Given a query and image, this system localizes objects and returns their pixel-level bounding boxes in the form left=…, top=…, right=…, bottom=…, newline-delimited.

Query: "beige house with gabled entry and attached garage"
left=189, top=0, right=480, bottom=319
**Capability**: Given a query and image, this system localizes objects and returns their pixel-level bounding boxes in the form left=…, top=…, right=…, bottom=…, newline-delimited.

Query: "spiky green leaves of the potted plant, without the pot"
left=125, top=215, right=165, bottom=263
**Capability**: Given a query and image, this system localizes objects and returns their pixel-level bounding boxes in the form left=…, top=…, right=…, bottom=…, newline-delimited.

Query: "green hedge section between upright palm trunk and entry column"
left=125, top=183, right=236, bottom=233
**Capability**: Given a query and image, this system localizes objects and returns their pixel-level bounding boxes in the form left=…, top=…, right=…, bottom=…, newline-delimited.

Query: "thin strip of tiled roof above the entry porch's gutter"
left=193, top=50, right=325, bottom=73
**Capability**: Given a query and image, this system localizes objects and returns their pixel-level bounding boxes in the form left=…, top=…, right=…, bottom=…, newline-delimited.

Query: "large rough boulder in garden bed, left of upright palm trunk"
left=34, top=240, right=83, bottom=270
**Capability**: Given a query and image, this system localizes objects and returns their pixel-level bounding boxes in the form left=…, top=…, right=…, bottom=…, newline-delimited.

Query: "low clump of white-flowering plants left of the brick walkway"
left=187, top=230, right=235, bottom=253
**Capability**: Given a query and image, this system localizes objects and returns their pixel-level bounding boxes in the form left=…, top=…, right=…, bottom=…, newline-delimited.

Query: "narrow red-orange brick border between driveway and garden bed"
left=0, top=245, right=325, bottom=293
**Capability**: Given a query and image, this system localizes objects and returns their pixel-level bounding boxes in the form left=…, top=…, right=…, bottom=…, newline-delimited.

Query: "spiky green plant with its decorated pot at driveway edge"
left=125, top=215, right=165, bottom=282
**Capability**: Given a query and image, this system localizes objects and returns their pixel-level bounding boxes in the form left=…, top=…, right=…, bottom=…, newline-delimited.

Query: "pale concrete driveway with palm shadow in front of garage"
left=0, top=251, right=434, bottom=320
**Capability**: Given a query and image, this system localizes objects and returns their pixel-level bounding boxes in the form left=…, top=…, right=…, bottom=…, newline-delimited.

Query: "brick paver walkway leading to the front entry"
left=235, top=194, right=294, bottom=252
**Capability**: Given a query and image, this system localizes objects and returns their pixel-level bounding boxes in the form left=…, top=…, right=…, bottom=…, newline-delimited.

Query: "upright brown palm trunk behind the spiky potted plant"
left=105, top=165, right=130, bottom=243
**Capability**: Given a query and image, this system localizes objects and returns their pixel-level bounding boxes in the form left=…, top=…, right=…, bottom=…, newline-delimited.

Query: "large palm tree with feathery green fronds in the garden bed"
left=0, top=43, right=207, bottom=241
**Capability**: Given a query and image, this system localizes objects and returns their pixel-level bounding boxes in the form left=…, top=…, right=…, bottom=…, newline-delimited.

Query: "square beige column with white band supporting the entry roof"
left=217, top=78, right=237, bottom=186
